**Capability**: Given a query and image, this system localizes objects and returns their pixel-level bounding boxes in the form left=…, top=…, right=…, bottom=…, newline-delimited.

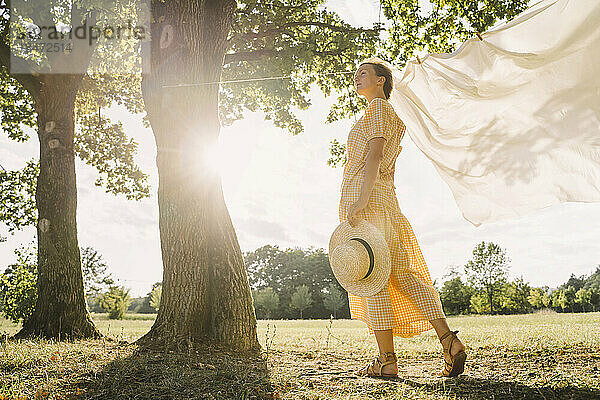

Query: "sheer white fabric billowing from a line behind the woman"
left=390, top=0, right=600, bottom=226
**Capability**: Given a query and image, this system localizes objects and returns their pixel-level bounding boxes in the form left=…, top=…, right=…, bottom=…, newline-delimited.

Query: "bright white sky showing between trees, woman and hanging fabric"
left=0, top=0, right=600, bottom=296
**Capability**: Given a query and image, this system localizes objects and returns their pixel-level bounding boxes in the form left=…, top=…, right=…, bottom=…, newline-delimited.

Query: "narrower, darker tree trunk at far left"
left=17, top=74, right=100, bottom=338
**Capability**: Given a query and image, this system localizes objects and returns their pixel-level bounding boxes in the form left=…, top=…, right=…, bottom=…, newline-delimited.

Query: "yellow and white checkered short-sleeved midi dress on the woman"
left=339, top=97, right=445, bottom=337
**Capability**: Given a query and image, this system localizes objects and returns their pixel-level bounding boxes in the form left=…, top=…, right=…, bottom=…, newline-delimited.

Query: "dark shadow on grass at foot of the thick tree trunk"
left=75, top=348, right=274, bottom=400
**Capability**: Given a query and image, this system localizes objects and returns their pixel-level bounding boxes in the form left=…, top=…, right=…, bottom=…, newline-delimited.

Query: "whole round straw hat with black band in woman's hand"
left=329, top=220, right=391, bottom=297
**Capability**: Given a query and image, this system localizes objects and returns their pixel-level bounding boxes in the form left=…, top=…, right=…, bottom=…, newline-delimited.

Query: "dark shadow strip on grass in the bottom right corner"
left=395, top=375, right=600, bottom=400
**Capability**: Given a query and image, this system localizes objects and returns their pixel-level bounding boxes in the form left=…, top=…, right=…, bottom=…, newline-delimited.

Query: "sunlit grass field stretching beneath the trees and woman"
left=0, top=312, right=600, bottom=400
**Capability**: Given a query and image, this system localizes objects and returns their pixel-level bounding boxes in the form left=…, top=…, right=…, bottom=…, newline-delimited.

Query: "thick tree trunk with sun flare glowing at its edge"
left=140, top=0, right=259, bottom=350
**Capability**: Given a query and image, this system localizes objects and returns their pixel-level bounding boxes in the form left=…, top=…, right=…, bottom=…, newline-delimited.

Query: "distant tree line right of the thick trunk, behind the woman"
left=244, top=242, right=600, bottom=319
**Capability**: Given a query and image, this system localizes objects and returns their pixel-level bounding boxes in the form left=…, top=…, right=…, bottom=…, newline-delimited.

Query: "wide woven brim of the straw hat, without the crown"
left=329, top=220, right=392, bottom=297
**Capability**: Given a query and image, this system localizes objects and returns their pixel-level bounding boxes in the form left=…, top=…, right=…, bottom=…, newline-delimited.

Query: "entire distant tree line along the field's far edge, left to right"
left=0, top=242, right=600, bottom=322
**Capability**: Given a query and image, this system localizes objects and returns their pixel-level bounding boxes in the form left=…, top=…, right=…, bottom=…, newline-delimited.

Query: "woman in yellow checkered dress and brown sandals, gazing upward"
left=339, top=58, right=466, bottom=377
